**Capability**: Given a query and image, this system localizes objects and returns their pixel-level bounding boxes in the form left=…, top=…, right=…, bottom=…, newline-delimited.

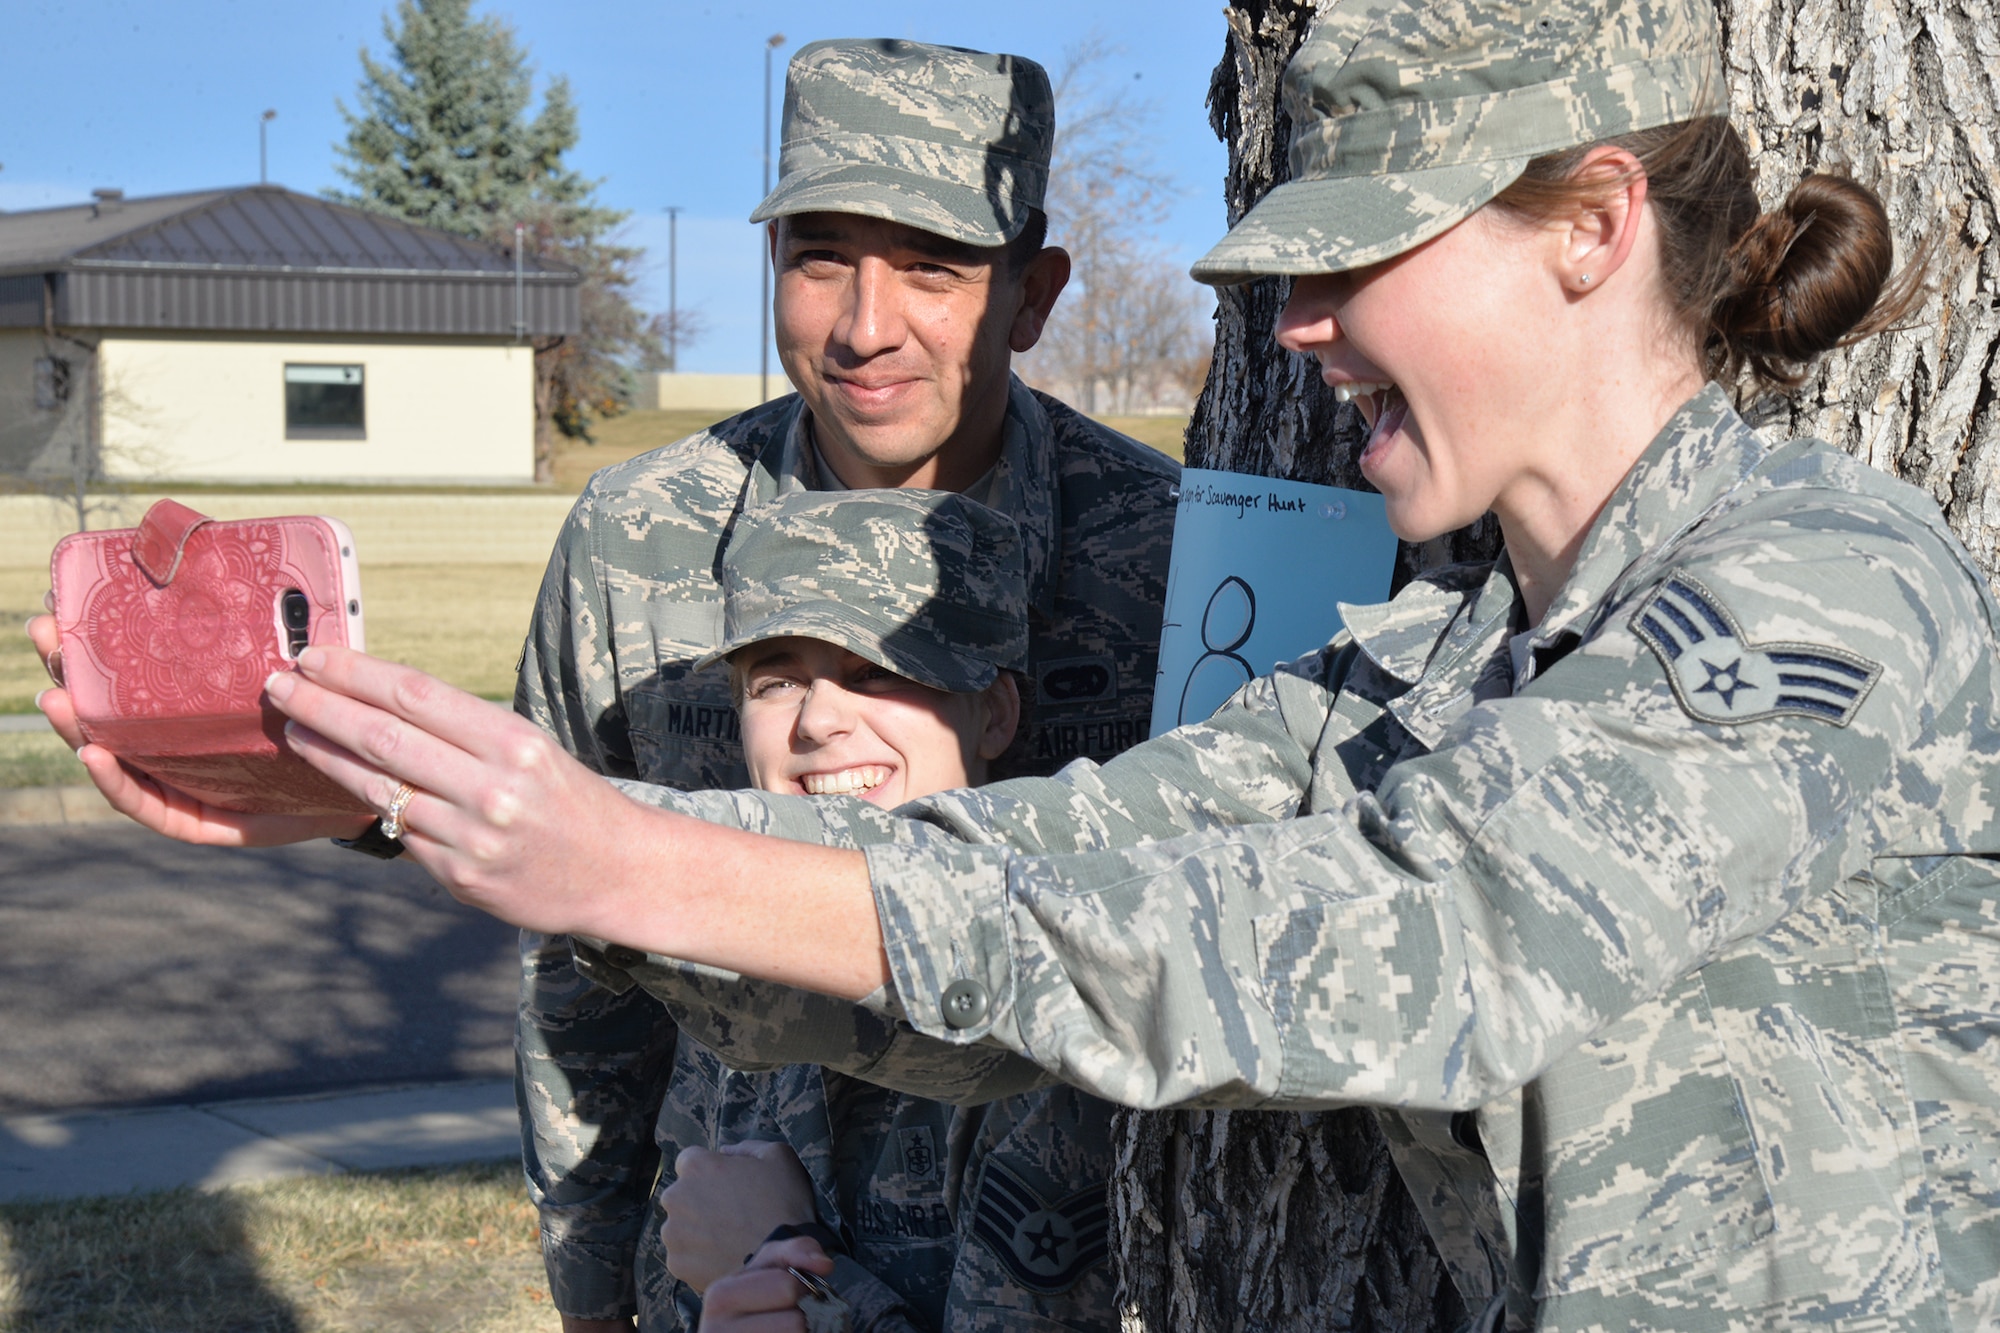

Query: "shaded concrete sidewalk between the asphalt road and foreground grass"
left=0, top=1079, right=520, bottom=1203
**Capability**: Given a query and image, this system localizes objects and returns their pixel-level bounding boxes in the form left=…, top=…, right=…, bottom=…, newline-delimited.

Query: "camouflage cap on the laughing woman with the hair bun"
left=1192, top=0, right=1722, bottom=286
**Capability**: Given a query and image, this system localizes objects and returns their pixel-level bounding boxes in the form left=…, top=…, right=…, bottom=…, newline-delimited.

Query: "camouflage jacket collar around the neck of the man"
left=746, top=374, right=1062, bottom=616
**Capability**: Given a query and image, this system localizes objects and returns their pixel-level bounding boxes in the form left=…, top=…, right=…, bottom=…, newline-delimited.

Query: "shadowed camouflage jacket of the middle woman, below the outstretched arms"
left=640, top=1041, right=1118, bottom=1333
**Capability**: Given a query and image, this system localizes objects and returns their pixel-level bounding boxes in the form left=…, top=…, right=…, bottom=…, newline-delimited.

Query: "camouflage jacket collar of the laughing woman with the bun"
left=1340, top=384, right=1766, bottom=745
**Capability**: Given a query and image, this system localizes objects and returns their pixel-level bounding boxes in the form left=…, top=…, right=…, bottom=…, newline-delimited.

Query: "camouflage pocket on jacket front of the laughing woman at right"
left=1516, top=975, right=1774, bottom=1299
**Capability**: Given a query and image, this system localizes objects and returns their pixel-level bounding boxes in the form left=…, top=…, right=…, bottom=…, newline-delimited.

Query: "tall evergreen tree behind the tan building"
left=330, top=0, right=658, bottom=480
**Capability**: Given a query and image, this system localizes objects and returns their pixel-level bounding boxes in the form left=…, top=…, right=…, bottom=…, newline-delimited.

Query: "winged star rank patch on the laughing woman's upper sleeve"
left=1632, top=574, right=1882, bottom=727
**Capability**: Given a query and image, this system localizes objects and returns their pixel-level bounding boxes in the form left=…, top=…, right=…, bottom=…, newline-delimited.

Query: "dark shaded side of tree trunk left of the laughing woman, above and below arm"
left=1112, top=0, right=1492, bottom=1333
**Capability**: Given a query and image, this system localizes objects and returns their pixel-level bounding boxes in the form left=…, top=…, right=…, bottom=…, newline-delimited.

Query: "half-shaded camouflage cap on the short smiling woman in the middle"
left=696, top=488, right=1028, bottom=693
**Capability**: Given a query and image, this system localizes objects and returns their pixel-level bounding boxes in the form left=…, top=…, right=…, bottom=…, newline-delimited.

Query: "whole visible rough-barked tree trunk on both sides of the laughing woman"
left=1112, top=0, right=2000, bottom=1333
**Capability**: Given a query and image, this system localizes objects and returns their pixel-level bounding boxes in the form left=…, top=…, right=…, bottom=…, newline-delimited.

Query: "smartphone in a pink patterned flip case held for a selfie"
left=50, top=500, right=368, bottom=815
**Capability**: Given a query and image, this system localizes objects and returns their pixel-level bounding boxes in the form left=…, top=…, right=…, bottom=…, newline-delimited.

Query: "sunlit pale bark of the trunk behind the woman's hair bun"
left=1718, top=0, right=2000, bottom=580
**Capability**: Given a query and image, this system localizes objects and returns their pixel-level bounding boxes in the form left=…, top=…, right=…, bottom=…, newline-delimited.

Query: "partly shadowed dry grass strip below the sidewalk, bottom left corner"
left=0, top=1163, right=556, bottom=1333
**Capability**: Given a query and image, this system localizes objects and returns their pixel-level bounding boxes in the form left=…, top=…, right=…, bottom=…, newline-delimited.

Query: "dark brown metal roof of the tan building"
left=0, top=186, right=582, bottom=336
